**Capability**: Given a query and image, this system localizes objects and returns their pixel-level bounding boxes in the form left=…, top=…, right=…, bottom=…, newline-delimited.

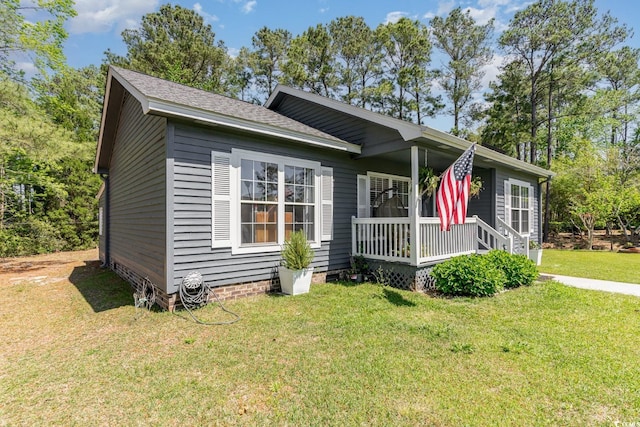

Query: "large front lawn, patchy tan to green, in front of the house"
left=0, top=262, right=640, bottom=426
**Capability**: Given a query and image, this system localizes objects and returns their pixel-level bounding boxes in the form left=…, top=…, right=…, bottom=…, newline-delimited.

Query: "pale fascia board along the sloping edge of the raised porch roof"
left=264, top=85, right=422, bottom=141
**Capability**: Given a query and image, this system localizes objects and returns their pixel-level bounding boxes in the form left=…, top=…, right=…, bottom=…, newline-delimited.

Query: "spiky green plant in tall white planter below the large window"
left=278, top=230, right=313, bottom=295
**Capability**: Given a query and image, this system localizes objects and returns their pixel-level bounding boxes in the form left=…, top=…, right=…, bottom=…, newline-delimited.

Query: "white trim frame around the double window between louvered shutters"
left=231, top=148, right=322, bottom=255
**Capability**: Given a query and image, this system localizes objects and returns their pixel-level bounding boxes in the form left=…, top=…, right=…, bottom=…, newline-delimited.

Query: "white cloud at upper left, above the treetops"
left=69, top=0, right=158, bottom=34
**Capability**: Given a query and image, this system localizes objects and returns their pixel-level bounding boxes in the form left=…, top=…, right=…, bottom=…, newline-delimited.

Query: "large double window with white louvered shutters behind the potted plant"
left=212, top=149, right=333, bottom=253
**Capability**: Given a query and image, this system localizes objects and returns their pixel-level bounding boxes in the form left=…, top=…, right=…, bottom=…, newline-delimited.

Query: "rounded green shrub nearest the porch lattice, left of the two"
left=431, top=254, right=505, bottom=297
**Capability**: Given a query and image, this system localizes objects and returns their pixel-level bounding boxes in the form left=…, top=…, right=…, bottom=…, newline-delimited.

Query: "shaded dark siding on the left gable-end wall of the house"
left=108, top=94, right=166, bottom=291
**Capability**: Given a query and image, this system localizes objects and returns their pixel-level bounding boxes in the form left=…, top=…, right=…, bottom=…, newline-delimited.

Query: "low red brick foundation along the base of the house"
left=110, top=260, right=327, bottom=311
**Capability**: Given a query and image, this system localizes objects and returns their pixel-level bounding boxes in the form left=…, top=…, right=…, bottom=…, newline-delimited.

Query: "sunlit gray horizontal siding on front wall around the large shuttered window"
left=168, top=122, right=408, bottom=292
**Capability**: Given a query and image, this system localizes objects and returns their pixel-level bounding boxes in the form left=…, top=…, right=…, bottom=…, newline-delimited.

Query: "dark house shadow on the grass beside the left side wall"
left=69, top=261, right=134, bottom=313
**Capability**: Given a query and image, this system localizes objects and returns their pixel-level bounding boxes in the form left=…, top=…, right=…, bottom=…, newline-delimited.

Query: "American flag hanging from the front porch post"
left=436, top=144, right=476, bottom=231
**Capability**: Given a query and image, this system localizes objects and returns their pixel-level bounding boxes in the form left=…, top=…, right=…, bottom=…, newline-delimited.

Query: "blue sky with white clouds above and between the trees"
left=53, top=0, right=640, bottom=130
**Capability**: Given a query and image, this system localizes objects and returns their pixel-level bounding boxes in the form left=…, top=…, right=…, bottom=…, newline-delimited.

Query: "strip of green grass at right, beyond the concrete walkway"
left=538, top=249, right=640, bottom=284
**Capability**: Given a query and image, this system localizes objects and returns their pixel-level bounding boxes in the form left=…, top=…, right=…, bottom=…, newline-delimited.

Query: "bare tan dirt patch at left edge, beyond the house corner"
left=0, top=249, right=99, bottom=285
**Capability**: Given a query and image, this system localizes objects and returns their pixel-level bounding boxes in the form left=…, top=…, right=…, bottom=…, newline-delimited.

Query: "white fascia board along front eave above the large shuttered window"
left=148, top=99, right=361, bottom=154
